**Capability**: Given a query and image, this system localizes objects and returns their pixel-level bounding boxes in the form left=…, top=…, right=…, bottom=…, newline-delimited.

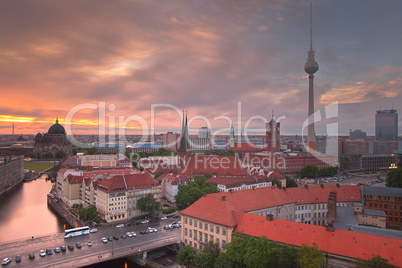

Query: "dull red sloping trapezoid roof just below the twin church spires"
left=180, top=155, right=247, bottom=176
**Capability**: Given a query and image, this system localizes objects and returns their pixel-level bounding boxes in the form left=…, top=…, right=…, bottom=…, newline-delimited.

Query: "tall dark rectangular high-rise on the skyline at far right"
left=375, top=109, right=398, bottom=141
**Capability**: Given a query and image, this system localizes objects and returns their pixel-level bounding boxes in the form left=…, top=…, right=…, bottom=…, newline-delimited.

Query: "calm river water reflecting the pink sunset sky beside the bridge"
left=0, top=178, right=65, bottom=242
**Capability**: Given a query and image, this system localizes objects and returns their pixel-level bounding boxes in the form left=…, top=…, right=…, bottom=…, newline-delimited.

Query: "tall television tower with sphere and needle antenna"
left=304, top=3, right=318, bottom=152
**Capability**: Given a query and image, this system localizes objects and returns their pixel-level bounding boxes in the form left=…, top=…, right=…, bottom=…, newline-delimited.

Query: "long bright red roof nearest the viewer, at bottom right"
left=234, top=213, right=402, bottom=266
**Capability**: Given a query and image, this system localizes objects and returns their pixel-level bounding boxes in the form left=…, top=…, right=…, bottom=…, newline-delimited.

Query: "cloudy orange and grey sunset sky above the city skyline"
left=0, top=0, right=402, bottom=135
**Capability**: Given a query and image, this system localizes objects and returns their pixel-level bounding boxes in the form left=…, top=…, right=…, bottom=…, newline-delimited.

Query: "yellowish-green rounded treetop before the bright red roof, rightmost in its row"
left=297, top=242, right=325, bottom=268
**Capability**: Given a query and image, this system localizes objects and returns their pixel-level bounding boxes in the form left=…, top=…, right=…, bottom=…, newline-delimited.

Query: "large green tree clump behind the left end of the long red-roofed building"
left=175, top=176, right=219, bottom=209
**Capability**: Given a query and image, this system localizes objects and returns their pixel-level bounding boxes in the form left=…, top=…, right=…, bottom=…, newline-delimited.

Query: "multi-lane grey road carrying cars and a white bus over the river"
left=0, top=220, right=181, bottom=267
